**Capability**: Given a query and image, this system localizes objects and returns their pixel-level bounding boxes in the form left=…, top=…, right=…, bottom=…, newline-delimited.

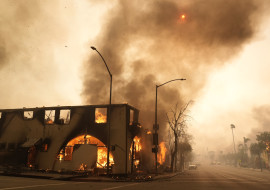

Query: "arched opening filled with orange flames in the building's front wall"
left=57, top=135, right=114, bottom=169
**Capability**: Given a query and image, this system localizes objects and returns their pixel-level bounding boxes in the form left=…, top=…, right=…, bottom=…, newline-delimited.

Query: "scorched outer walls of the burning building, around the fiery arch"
left=0, top=104, right=142, bottom=173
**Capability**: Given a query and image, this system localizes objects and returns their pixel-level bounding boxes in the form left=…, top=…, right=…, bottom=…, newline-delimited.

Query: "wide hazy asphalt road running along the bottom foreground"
left=0, top=165, right=270, bottom=190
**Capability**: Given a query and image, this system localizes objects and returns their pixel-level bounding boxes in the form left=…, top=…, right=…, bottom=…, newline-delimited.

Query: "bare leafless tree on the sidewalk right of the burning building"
left=166, top=102, right=191, bottom=172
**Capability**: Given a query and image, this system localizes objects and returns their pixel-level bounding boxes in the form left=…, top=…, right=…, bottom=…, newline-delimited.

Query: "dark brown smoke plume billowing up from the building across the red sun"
left=82, top=0, right=263, bottom=137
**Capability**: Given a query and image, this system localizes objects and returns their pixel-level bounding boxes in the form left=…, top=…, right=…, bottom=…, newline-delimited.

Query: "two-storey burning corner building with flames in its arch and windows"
left=0, top=104, right=141, bottom=174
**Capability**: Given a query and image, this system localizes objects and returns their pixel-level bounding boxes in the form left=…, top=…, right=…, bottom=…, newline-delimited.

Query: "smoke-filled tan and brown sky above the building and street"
left=0, top=0, right=270, bottom=152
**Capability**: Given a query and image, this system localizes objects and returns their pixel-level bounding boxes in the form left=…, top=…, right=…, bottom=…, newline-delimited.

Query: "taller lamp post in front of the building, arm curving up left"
left=91, top=46, right=112, bottom=175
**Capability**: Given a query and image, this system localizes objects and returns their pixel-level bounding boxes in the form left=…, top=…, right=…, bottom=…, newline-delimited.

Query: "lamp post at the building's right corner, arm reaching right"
left=153, top=79, right=186, bottom=175
